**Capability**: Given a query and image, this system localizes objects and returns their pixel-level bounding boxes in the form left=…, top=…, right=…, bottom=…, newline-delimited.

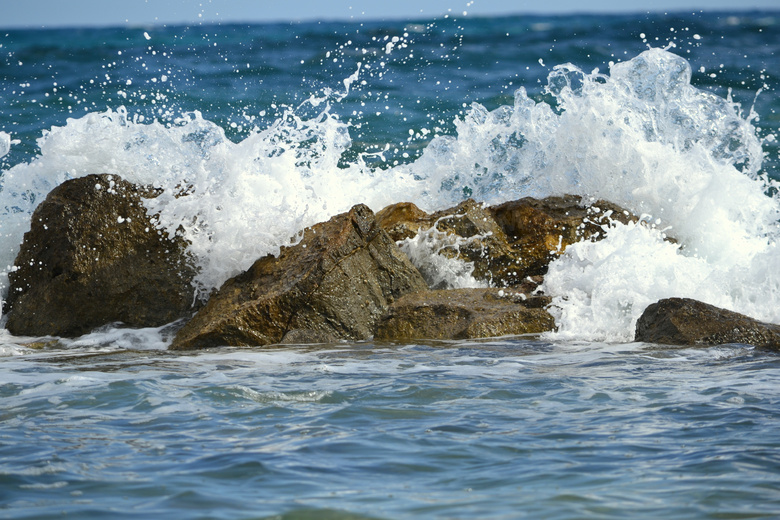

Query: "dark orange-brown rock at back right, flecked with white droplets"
left=488, top=195, right=639, bottom=280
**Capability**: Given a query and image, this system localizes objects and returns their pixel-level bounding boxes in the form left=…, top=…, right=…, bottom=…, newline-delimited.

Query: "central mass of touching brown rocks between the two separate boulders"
left=171, top=193, right=631, bottom=350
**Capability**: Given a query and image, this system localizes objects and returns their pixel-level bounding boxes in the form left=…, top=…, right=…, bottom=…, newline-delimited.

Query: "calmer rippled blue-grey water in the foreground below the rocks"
left=0, top=339, right=780, bottom=518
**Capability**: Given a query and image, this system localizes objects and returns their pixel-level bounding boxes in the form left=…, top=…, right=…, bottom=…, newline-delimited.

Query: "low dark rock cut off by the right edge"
left=636, top=298, right=780, bottom=350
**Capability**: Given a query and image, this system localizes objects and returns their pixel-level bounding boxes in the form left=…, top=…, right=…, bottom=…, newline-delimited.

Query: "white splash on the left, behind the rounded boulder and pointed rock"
left=0, top=100, right=420, bottom=300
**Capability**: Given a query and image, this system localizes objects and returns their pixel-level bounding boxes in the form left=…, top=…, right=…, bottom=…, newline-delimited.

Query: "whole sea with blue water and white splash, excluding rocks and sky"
left=0, top=11, right=780, bottom=519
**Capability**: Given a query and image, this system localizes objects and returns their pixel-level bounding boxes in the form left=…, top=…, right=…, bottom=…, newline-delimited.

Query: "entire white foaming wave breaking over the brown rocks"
left=0, top=49, right=780, bottom=341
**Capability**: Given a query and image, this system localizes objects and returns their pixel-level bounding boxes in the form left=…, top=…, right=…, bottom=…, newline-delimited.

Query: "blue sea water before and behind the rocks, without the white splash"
left=0, top=12, right=780, bottom=519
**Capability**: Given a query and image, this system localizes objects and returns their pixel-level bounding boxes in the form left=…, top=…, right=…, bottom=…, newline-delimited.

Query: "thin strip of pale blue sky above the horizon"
left=0, top=0, right=780, bottom=28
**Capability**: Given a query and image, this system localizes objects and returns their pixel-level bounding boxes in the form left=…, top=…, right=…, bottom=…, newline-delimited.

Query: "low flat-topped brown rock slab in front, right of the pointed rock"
left=375, top=289, right=555, bottom=341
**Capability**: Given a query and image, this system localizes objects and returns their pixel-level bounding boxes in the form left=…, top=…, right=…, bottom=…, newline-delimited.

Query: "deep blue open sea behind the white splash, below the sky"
left=0, top=12, right=780, bottom=171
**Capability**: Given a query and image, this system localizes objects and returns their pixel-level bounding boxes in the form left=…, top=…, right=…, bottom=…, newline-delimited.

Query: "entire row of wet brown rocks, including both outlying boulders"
left=5, top=175, right=780, bottom=350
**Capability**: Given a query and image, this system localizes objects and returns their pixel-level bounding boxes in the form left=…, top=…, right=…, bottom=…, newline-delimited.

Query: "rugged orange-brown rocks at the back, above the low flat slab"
left=377, top=195, right=638, bottom=289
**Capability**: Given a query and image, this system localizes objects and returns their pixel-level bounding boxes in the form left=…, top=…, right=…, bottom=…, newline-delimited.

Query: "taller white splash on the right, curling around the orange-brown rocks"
left=396, top=49, right=780, bottom=341
